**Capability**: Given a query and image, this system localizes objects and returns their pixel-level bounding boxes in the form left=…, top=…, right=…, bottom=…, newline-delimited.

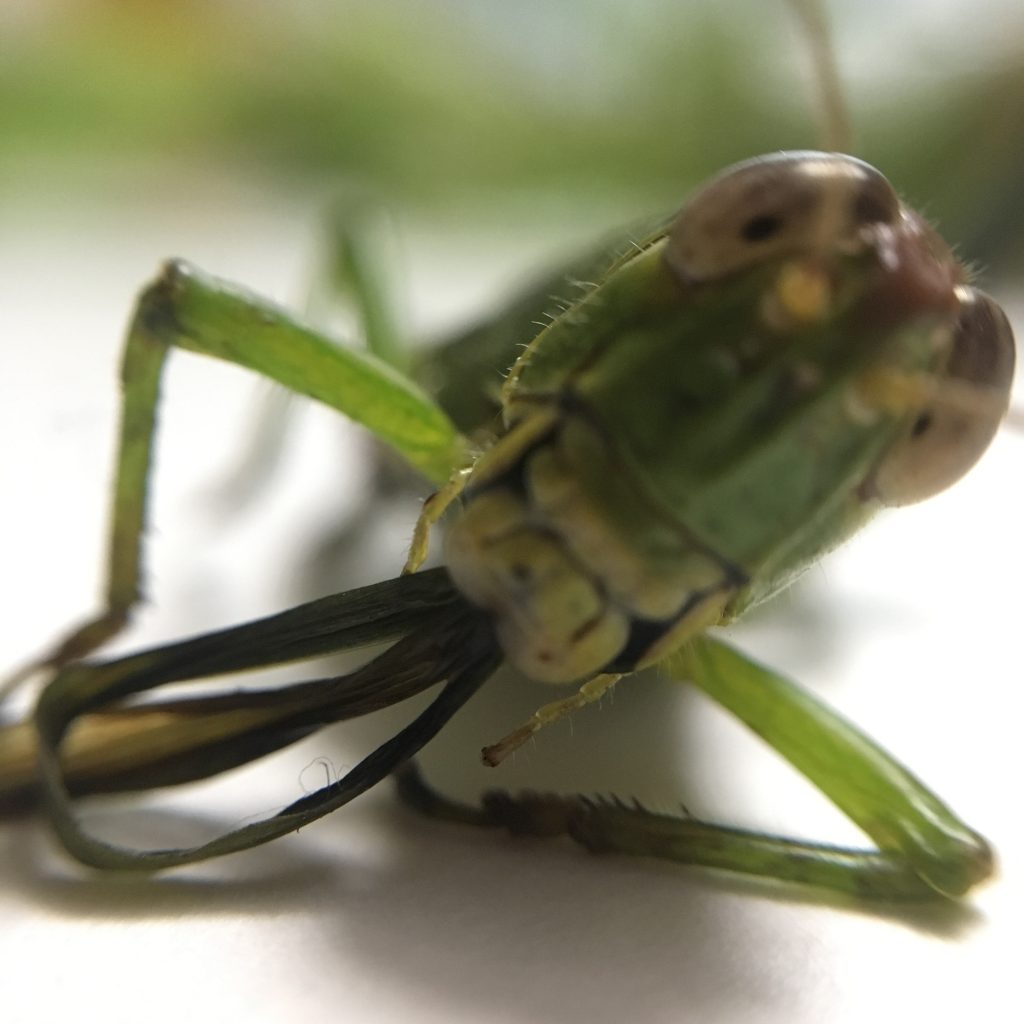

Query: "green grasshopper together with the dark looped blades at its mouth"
left=0, top=2, right=1014, bottom=899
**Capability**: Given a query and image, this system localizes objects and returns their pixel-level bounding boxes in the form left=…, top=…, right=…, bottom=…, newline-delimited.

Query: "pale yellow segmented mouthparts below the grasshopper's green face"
left=446, top=409, right=742, bottom=683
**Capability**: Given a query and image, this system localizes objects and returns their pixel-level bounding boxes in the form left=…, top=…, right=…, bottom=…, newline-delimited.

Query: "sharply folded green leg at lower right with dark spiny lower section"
left=398, top=637, right=992, bottom=900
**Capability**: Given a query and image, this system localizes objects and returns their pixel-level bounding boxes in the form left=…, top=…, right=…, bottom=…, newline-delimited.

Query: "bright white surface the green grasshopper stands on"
left=0, top=183, right=1024, bottom=1024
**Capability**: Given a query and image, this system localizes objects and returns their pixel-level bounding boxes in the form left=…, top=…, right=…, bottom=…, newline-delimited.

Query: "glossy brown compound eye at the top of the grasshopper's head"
left=665, top=153, right=900, bottom=283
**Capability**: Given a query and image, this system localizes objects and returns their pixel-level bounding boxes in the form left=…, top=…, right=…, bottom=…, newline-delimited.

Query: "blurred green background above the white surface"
left=0, top=0, right=1024, bottom=270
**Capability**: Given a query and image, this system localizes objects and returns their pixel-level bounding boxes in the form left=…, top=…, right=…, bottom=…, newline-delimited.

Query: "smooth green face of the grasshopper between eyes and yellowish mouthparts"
left=505, top=235, right=944, bottom=608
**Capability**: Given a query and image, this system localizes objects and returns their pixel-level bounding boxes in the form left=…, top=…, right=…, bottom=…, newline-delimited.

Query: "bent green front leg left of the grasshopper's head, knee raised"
left=9, top=262, right=463, bottom=668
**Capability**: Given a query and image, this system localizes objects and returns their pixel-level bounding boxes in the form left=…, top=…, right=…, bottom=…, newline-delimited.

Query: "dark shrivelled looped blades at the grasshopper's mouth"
left=28, top=570, right=501, bottom=870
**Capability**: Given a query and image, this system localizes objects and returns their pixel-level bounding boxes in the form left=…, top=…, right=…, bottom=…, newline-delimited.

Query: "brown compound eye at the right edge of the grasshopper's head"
left=869, top=287, right=1014, bottom=505
